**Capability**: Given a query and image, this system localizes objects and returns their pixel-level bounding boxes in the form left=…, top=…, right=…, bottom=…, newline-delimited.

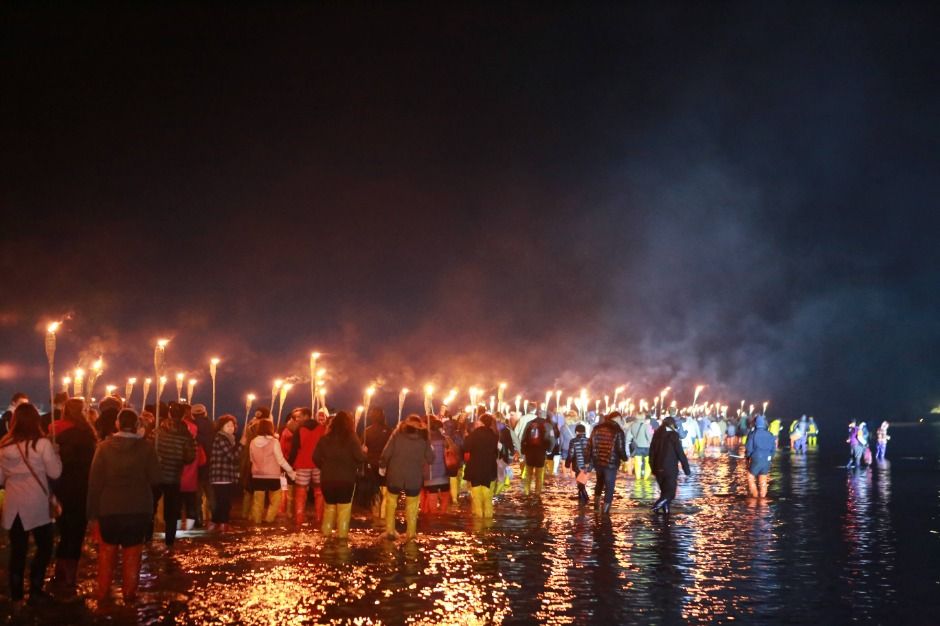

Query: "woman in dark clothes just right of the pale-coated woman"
left=51, top=398, right=98, bottom=591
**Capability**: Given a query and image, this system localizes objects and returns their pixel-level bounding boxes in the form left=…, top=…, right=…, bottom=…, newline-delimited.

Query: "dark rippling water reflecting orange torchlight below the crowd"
left=0, top=426, right=940, bottom=625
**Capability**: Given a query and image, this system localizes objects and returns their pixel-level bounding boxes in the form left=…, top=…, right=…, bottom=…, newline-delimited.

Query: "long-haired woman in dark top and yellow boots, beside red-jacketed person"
left=313, top=411, right=366, bottom=539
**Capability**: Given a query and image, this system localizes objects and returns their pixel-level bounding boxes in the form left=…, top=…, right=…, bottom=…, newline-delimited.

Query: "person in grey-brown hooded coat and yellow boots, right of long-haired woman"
left=381, top=415, right=436, bottom=540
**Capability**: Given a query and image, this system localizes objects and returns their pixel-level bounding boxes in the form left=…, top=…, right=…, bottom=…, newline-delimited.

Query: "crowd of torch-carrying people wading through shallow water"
left=0, top=392, right=889, bottom=603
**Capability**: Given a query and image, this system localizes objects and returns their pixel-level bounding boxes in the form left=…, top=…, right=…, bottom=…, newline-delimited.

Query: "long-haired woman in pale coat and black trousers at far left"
left=0, top=402, right=62, bottom=605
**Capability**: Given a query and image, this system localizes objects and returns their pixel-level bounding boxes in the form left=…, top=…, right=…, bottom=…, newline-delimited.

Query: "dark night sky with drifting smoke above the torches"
left=0, top=2, right=940, bottom=421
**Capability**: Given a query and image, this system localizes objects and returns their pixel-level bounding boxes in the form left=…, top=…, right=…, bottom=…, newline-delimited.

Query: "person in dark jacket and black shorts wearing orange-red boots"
left=86, top=407, right=162, bottom=603
